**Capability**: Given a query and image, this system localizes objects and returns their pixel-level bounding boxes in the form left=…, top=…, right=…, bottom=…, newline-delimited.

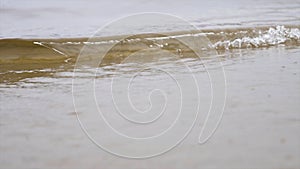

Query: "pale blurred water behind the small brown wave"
left=0, top=0, right=300, bottom=38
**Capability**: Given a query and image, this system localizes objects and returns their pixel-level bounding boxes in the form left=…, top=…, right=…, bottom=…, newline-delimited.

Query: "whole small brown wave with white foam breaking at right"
left=0, top=26, right=300, bottom=62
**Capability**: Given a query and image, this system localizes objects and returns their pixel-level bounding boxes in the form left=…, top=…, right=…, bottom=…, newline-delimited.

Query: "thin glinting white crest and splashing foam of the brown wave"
left=28, top=26, right=300, bottom=53
